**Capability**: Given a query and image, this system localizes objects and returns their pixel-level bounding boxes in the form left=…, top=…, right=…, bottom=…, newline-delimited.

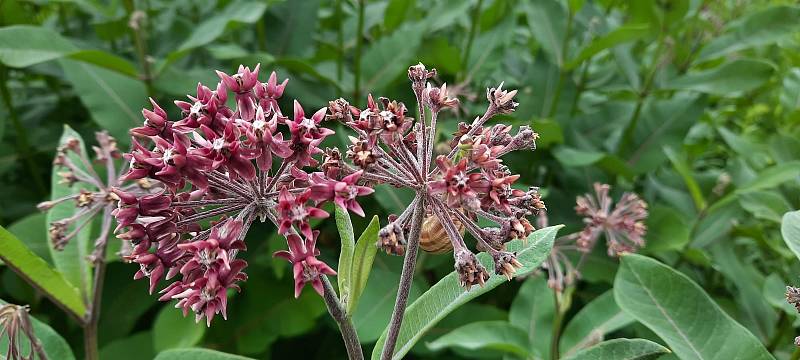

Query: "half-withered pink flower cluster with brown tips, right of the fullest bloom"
left=324, top=64, right=544, bottom=289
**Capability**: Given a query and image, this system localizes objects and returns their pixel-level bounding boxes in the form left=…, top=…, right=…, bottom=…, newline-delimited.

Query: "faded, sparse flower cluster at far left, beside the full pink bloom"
left=38, top=131, right=139, bottom=261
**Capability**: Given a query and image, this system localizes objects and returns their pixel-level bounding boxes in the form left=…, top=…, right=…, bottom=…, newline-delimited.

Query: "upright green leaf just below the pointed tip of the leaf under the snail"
left=508, top=276, right=556, bottom=359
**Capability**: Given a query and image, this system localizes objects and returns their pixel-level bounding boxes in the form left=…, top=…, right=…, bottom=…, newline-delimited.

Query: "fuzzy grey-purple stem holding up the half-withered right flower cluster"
left=381, top=197, right=425, bottom=360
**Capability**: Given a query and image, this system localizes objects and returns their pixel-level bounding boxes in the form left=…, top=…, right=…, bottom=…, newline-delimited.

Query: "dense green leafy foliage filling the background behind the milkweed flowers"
left=0, top=0, right=800, bottom=359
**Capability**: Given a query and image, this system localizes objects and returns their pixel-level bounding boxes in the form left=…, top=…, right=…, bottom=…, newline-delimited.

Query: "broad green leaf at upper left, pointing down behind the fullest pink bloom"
left=59, top=59, right=147, bottom=143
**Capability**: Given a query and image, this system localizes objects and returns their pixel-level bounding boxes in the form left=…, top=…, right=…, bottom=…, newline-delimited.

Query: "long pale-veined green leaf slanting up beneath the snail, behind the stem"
left=372, top=226, right=561, bottom=359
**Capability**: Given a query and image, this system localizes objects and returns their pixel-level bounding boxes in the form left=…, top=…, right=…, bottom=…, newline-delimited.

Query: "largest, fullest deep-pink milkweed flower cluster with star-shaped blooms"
left=114, top=66, right=372, bottom=323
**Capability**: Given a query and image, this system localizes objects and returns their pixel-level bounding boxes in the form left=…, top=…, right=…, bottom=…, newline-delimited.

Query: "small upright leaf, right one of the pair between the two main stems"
left=346, top=215, right=381, bottom=316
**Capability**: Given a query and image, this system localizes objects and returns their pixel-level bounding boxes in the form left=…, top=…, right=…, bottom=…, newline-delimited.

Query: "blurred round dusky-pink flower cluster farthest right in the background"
left=575, top=183, right=647, bottom=256
